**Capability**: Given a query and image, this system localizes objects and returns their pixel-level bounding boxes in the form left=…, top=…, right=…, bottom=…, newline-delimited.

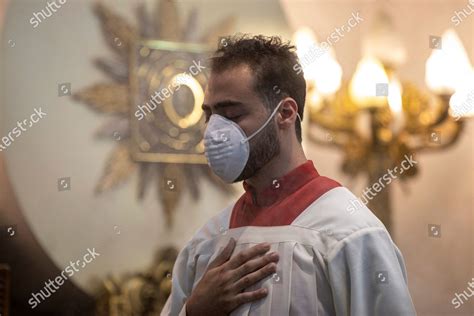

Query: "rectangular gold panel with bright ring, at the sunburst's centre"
left=130, top=40, right=210, bottom=164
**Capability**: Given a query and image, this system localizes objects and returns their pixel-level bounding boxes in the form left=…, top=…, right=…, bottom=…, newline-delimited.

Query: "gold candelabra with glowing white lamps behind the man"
left=295, top=24, right=474, bottom=230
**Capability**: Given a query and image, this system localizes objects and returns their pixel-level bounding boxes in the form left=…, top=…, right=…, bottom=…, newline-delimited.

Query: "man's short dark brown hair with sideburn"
left=211, top=34, right=306, bottom=142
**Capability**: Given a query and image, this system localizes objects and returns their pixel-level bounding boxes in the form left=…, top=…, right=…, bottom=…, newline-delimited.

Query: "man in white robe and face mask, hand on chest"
left=162, top=36, right=415, bottom=316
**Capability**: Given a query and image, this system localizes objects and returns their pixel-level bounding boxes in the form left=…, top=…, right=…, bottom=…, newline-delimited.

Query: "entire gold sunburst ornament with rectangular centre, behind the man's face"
left=73, top=0, right=234, bottom=227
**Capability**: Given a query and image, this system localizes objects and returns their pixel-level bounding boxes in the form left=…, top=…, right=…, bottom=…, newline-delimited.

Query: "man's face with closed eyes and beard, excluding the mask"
left=202, top=65, right=280, bottom=182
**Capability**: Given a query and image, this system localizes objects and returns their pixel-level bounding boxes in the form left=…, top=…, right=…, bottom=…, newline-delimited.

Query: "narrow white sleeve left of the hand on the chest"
left=160, top=242, right=195, bottom=316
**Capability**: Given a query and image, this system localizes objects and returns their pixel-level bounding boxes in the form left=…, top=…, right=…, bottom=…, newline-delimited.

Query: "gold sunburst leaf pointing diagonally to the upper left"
left=94, top=2, right=137, bottom=60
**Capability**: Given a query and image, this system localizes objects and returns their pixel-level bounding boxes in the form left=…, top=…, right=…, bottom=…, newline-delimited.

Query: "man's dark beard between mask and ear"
left=234, top=120, right=280, bottom=182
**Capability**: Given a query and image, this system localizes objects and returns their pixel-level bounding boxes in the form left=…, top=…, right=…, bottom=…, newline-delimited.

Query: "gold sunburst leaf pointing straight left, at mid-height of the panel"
left=73, top=83, right=129, bottom=114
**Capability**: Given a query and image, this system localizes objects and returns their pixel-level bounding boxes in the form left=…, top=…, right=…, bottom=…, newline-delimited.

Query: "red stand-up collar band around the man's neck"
left=242, top=160, right=319, bottom=207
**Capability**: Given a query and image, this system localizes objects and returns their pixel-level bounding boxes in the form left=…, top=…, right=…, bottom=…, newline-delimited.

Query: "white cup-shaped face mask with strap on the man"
left=204, top=100, right=301, bottom=183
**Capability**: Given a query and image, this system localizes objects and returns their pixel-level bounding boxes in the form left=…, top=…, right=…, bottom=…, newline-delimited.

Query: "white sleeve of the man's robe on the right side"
left=327, top=228, right=416, bottom=316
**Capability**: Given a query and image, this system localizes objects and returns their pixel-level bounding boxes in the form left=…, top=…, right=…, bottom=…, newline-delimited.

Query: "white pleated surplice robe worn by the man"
left=161, top=187, right=416, bottom=316
